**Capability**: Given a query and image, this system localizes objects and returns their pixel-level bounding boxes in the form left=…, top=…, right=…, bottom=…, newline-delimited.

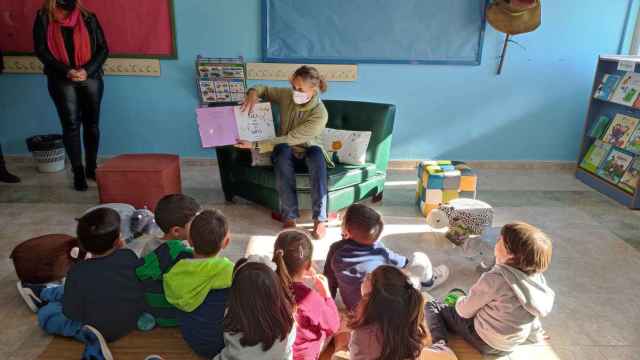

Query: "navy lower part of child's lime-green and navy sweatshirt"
left=178, top=289, right=229, bottom=359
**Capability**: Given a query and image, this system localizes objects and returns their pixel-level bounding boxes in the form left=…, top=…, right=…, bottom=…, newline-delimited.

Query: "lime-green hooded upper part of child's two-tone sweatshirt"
left=163, top=256, right=233, bottom=312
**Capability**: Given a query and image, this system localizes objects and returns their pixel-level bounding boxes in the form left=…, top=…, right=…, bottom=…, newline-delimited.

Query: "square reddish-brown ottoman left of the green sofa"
left=96, top=154, right=182, bottom=211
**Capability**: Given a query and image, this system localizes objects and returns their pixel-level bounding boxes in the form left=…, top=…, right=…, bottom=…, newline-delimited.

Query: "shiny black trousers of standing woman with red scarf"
left=48, top=76, right=104, bottom=170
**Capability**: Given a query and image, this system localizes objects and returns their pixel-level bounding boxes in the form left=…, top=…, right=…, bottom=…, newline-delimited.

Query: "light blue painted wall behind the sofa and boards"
left=0, top=0, right=637, bottom=160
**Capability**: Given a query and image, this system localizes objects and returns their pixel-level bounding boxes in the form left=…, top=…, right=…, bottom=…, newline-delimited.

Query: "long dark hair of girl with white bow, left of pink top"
left=223, top=260, right=295, bottom=351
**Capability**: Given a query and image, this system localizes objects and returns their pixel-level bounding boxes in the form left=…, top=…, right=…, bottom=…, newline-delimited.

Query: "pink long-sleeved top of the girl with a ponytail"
left=292, top=282, right=340, bottom=360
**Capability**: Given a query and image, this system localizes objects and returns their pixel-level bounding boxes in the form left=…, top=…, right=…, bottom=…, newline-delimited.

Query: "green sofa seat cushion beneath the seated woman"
left=233, top=163, right=377, bottom=191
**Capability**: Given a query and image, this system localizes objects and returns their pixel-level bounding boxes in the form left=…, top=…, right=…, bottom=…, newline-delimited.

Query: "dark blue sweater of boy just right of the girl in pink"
left=324, top=239, right=408, bottom=311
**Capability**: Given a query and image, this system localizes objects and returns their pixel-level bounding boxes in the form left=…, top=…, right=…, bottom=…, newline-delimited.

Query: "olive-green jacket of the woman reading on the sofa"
left=253, top=86, right=334, bottom=167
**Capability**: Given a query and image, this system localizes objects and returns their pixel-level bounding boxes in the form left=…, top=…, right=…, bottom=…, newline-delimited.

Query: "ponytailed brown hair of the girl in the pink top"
left=273, top=229, right=313, bottom=304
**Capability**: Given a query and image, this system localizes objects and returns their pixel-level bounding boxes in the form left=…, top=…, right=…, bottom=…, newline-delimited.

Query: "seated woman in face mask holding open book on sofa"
left=236, top=65, right=333, bottom=239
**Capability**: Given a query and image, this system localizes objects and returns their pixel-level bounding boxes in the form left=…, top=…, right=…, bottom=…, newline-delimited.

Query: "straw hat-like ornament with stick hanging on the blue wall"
left=487, top=0, right=542, bottom=75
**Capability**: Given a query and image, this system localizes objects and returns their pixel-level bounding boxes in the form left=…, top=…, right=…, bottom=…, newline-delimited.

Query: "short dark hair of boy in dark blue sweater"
left=342, top=204, right=384, bottom=243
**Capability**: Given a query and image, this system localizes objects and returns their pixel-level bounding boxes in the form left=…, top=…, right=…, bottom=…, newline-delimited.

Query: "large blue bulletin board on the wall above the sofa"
left=262, top=0, right=488, bottom=65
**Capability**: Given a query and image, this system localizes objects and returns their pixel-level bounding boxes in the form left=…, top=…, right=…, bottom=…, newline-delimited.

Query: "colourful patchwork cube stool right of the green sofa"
left=416, top=160, right=478, bottom=216
